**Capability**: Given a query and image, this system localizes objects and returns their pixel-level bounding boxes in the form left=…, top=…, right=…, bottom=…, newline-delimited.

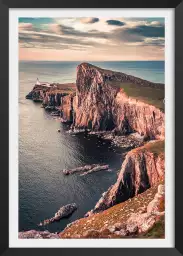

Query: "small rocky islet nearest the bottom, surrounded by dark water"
left=39, top=203, right=77, bottom=226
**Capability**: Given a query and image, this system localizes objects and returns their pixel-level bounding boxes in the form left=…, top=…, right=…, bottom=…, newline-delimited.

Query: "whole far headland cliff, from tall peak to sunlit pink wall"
left=75, top=63, right=164, bottom=139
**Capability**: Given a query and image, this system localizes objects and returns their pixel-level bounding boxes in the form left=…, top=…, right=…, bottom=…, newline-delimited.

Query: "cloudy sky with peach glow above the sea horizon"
left=19, top=17, right=165, bottom=61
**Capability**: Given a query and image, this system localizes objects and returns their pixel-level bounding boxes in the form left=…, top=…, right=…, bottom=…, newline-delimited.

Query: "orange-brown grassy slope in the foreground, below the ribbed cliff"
left=60, top=183, right=163, bottom=238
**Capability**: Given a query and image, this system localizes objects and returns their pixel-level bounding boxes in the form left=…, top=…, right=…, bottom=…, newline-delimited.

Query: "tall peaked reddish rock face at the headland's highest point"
left=75, top=64, right=119, bottom=130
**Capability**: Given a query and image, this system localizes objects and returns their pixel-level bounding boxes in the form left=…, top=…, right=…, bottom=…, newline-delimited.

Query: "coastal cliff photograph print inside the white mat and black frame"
left=18, top=16, right=166, bottom=240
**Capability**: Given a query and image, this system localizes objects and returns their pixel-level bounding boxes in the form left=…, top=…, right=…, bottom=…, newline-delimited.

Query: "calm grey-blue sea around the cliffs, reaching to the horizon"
left=19, top=61, right=165, bottom=232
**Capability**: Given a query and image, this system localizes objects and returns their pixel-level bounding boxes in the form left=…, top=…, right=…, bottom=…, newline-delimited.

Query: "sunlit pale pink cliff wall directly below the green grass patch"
left=113, top=90, right=164, bottom=139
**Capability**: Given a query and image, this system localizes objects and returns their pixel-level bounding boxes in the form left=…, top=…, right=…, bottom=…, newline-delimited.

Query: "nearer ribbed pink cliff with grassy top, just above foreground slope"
left=86, top=141, right=164, bottom=216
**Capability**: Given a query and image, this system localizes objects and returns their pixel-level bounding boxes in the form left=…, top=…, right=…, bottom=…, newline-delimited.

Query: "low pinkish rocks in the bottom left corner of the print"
left=18, top=230, right=60, bottom=239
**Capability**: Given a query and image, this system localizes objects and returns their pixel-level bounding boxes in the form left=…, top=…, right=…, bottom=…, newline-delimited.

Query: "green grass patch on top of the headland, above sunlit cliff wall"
left=112, top=82, right=164, bottom=112
